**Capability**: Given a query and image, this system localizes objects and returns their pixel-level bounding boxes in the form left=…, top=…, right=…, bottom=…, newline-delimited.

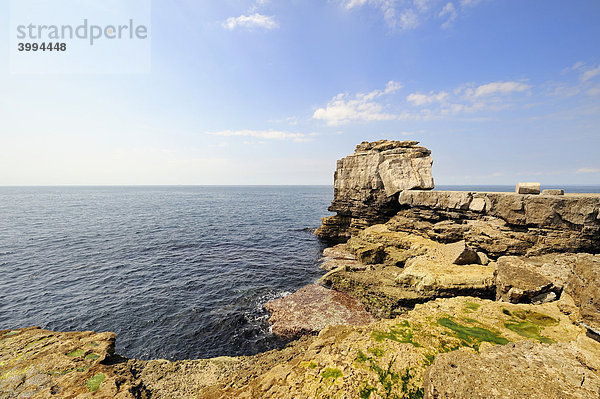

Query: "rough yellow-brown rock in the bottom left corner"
left=0, top=327, right=137, bottom=399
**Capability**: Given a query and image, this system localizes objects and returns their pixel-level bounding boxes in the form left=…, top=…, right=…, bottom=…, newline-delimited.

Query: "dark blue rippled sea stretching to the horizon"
left=0, top=186, right=600, bottom=360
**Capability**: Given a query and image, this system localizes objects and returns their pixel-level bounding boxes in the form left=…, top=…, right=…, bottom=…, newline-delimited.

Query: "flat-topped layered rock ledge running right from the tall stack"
left=394, top=190, right=600, bottom=257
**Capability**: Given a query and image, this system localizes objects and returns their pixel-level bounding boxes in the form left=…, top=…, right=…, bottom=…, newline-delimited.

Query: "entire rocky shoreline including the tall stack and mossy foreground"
left=0, top=140, right=600, bottom=398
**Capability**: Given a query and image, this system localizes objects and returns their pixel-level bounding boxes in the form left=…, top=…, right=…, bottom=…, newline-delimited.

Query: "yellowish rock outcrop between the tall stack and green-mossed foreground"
left=320, top=224, right=495, bottom=317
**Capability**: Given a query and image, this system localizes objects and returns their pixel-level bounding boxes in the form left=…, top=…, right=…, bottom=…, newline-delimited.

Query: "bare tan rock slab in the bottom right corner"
left=424, top=341, right=600, bottom=399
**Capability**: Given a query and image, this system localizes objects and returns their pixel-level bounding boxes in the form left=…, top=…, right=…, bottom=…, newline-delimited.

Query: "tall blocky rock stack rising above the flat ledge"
left=315, top=140, right=434, bottom=240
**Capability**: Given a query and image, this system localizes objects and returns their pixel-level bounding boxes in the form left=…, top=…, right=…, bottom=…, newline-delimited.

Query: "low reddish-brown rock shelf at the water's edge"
left=265, top=284, right=374, bottom=339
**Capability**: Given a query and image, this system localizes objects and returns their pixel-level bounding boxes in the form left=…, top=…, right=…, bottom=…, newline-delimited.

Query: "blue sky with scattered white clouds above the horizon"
left=0, top=0, right=600, bottom=186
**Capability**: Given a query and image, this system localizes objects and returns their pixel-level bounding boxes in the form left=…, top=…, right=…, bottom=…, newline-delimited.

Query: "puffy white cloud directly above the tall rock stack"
left=313, top=81, right=402, bottom=126
